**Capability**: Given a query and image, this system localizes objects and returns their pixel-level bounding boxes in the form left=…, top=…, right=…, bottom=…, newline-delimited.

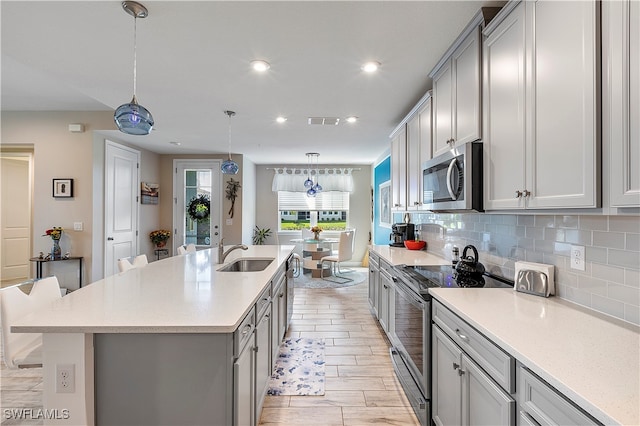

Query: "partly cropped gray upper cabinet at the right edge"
left=602, top=0, right=640, bottom=207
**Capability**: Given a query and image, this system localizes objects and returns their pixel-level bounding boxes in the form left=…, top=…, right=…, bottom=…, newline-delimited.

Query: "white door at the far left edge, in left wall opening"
left=0, top=153, right=31, bottom=286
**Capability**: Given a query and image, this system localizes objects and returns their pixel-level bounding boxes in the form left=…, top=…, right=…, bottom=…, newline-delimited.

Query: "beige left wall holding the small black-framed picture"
left=0, top=111, right=160, bottom=289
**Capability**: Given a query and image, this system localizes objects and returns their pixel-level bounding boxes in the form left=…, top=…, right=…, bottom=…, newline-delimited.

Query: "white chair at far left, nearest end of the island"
left=0, top=276, right=62, bottom=369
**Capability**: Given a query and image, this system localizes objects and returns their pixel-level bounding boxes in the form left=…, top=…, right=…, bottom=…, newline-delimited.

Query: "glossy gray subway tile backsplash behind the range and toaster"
left=396, top=213, right=640, bottom=325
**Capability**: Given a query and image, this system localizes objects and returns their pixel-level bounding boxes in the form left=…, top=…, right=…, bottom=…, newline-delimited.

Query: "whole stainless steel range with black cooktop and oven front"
left=390, top=265, right=513, bottom=426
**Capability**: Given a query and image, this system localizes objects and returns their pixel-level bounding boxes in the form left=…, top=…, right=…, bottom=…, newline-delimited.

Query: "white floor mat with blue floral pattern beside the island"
left=267, top=338, right=324, bottom=395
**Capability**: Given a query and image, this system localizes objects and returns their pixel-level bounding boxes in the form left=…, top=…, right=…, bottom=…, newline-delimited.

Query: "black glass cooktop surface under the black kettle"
left=395, top=265, right=513, bottom=295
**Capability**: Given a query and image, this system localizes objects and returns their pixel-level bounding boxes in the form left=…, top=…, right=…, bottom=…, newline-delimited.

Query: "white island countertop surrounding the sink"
left=13, top=245, right=295, bottom=333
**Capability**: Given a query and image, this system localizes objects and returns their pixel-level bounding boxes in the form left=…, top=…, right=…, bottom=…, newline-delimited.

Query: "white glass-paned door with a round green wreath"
left=173, top=160, right=222, bottom=252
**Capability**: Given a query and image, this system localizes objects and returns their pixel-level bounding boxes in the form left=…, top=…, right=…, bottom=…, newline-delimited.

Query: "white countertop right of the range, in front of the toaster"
left=429, top=288, right=640, bottom=425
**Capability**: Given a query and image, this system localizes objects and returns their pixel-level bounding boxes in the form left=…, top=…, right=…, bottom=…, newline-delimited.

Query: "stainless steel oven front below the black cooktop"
left=390, top=277, right=431, bottom=425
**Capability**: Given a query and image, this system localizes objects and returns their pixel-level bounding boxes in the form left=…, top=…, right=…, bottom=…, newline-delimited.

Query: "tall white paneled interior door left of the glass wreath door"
left=104, top=141, right=140, bottom=277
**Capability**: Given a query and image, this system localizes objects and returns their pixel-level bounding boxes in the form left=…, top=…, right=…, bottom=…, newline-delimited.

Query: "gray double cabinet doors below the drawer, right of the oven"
left=432, top=326, right=516, bottom=426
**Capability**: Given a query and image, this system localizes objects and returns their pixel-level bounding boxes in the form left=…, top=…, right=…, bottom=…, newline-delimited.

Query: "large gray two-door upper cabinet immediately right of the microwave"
left=483, top=1, right=600, bottom=210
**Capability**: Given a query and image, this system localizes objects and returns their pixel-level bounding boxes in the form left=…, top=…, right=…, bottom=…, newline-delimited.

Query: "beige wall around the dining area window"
left=256, top=164, right=371, bottom=263
